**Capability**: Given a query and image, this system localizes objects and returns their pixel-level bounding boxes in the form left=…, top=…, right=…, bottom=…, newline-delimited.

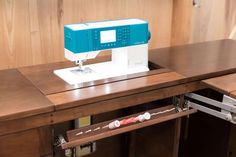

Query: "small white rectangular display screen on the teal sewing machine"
left=100, top=30, right=116, bottom=44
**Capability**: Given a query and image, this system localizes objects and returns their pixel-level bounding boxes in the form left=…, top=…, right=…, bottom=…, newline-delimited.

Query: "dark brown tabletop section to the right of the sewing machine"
left=149, top=40, right=236, bottom=80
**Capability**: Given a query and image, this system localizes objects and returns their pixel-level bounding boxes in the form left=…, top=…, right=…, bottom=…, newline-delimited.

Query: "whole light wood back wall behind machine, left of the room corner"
left=0, top=0, right=172, bottom=69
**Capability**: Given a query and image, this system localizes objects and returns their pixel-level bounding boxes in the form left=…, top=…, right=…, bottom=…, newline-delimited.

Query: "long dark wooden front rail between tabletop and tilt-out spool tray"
left=52, top=82, right=204, bottom=123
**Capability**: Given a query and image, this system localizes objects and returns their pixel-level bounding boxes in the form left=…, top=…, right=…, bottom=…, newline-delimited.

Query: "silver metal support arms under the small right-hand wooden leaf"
left=185, top=93, right=236, bottom=124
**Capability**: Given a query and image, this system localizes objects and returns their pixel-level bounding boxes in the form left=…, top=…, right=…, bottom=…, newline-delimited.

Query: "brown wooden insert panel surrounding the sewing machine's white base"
left=19, top=56, right=170, bottom=95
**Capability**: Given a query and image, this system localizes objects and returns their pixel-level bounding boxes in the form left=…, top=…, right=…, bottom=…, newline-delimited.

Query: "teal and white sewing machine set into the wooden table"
left=54, top=19, right=150, bottom=84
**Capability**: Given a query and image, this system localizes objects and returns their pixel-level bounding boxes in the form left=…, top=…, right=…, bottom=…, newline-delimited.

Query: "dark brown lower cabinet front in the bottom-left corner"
left=0, top=126, right=53, bottom=157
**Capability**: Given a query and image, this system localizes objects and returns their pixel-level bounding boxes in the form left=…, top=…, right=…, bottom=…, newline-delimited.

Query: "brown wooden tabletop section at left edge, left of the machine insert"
left=0, top=69, right=54, bottom=121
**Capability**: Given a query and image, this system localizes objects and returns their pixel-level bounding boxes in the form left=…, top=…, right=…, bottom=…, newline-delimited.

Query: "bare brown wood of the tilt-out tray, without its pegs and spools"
left=61, top=105, right=196, bottom=149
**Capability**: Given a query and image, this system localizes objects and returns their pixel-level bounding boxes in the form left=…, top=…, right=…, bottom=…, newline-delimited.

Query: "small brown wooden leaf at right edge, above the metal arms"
left=202, top=73, right=236, bottom=98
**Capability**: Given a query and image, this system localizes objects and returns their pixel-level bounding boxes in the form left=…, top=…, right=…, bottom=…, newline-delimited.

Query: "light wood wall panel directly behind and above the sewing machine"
left=64, top=0, right=172, bottom=48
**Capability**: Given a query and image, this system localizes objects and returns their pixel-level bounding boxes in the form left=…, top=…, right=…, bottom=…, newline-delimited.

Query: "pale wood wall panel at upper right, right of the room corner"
left=190, top=0, right=227, bottom=42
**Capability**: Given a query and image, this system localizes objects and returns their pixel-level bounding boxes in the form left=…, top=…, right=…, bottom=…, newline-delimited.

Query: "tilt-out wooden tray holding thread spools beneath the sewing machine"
left=61, top=105, right=196, bottom=149
